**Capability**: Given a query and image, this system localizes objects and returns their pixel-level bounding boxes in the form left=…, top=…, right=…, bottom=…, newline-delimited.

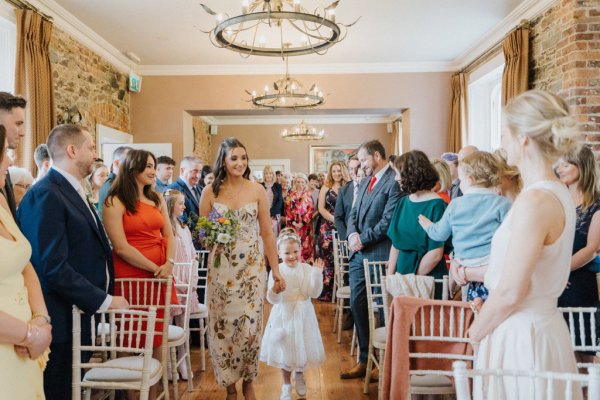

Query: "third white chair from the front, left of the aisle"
left=167, top=262, right=196, bottom=399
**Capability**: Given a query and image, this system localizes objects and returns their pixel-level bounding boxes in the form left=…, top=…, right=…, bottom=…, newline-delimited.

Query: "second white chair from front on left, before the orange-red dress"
left=115, top=275, right=174, bottom=400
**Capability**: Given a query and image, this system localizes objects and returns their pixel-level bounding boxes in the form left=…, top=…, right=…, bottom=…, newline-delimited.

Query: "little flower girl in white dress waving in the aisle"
left=260, top=228, right=325, bottom=400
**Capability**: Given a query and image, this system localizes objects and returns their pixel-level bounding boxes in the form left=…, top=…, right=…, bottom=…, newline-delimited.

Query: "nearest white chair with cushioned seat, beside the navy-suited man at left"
left=72, top=306, right=162, bottom=400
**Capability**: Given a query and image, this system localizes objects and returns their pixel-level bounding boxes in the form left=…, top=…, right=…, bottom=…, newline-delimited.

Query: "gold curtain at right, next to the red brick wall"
left=502, top=27, right=529, bottom=105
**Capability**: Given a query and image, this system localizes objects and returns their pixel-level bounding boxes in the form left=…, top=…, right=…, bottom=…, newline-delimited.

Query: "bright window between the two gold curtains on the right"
left=467, top=53, right=504, bottom=151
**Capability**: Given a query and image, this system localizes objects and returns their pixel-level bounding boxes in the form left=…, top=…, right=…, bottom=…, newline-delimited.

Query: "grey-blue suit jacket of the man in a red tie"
left=347, top=168, right=401, bottom=261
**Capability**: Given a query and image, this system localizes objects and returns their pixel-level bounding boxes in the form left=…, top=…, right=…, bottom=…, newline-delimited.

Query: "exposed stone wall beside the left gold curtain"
left=50, top=26, right=130, bottom=141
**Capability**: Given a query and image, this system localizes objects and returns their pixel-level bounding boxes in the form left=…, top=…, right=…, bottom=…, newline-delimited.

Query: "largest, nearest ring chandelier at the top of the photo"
left=200, top=0, right=358, bottom=58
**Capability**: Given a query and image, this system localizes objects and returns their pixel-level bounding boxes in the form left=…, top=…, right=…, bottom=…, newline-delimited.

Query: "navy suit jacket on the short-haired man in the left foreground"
left=17, top=169, right=114, bottom=343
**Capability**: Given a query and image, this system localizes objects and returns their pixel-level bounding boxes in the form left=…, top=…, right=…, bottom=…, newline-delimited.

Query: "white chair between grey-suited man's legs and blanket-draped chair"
left=363, top=259, right=389, bottom=398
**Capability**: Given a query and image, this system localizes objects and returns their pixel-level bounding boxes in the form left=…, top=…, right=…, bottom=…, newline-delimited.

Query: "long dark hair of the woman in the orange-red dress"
left=104, top=150, right=160, bottom=214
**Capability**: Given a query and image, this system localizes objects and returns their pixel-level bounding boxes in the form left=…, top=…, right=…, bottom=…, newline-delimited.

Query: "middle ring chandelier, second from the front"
left=246, top=58, right=325, bottom=110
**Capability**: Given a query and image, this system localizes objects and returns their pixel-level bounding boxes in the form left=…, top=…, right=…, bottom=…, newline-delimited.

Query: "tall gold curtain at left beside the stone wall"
left=15, top=9, right=56, bottom=171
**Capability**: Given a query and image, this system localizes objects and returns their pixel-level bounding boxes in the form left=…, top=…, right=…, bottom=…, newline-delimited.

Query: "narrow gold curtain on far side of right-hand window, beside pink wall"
left=448, top=72, right=467, bottom=153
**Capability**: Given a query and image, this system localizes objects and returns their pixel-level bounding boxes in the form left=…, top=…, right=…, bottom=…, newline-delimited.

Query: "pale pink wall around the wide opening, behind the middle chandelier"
left=131, top=73, right=451, bottom=162
